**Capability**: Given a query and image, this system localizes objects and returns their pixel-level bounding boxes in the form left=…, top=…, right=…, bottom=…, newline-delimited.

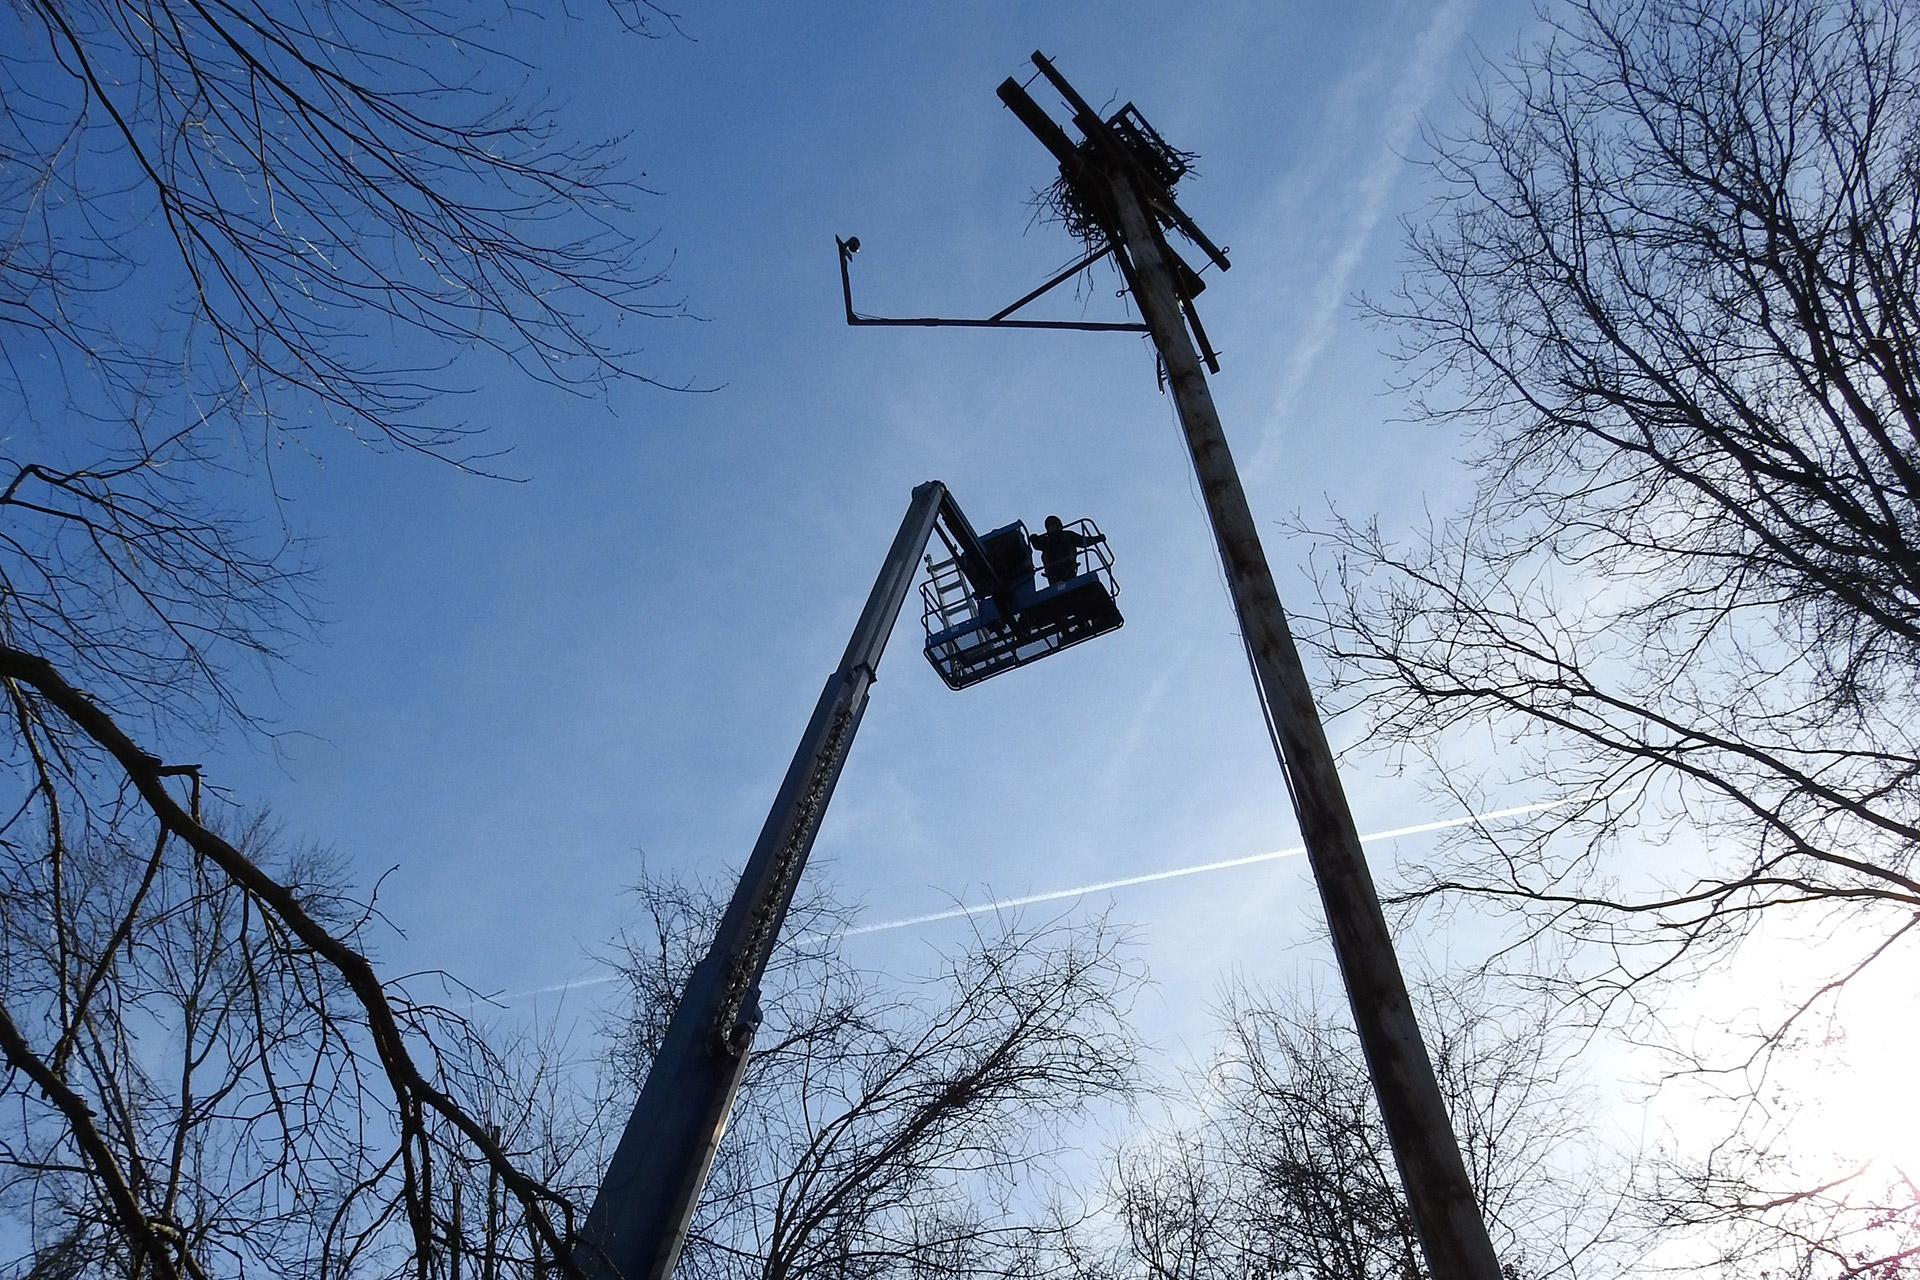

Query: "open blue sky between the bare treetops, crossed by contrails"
left=194, top=0, right=1530, bottom=1040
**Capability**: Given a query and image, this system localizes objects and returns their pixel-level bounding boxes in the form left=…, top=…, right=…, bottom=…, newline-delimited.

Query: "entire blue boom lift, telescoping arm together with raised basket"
left=572, top=480, right=1121, bottom=1280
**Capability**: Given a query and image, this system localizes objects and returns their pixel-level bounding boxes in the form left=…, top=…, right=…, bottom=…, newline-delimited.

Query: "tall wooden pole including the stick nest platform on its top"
left=1000, top=54, right=1501, bottom=1280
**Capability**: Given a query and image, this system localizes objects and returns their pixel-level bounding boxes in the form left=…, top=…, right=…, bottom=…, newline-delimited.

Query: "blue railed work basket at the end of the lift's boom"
left=920, top=520, right=1123, bottom=689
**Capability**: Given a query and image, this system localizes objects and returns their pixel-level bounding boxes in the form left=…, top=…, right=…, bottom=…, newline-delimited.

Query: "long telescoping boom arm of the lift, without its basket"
left=574, top=480, right=1004, bottom=1280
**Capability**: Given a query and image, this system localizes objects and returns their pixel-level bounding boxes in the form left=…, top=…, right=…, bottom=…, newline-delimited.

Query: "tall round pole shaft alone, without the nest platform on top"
left=1106, top=173, right=1501, bottom=1280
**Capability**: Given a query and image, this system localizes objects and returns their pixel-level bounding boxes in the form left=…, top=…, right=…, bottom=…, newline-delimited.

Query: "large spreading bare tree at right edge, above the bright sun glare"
left=1321, top=0, right=1920, bottom=1274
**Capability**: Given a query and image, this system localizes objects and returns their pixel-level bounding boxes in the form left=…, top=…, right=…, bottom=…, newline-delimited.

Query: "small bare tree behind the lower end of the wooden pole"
left=1106, top=984, right=1632, bottom=1280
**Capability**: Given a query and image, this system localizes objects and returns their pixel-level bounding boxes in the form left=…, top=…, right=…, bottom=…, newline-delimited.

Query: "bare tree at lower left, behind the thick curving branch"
left=0, top=805, right=606, bottom=1278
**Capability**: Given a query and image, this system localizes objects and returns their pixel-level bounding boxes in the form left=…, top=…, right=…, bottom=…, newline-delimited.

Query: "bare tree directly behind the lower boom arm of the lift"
left=602, top=879, right=1140, bottom=1280
